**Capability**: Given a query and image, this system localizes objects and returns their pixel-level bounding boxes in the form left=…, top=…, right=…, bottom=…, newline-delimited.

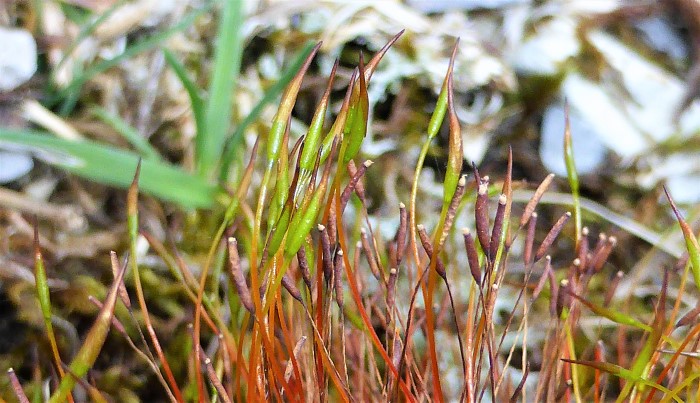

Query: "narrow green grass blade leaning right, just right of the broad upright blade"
left=219, top=41, right=315, bottom=183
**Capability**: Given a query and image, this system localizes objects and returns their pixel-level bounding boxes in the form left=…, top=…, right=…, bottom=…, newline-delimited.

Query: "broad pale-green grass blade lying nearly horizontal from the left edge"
left=0, top=128, right=217, bottom=208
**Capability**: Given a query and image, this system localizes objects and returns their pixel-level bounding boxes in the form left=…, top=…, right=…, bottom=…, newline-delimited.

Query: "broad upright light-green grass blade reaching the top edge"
left=196, top=1, right=244, bottom=178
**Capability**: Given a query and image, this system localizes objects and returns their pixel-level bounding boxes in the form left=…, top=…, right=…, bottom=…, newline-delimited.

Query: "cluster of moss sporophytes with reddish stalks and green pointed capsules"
left=10, top=29, right=700, bottom=402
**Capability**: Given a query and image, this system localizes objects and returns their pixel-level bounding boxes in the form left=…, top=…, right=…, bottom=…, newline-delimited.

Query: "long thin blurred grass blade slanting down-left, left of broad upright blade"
left=55, top=3, right=212, bottom=115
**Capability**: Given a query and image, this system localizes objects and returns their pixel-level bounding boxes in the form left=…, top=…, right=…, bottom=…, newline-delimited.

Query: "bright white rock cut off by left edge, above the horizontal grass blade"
left=0, top=27, right=36, bottom=91
